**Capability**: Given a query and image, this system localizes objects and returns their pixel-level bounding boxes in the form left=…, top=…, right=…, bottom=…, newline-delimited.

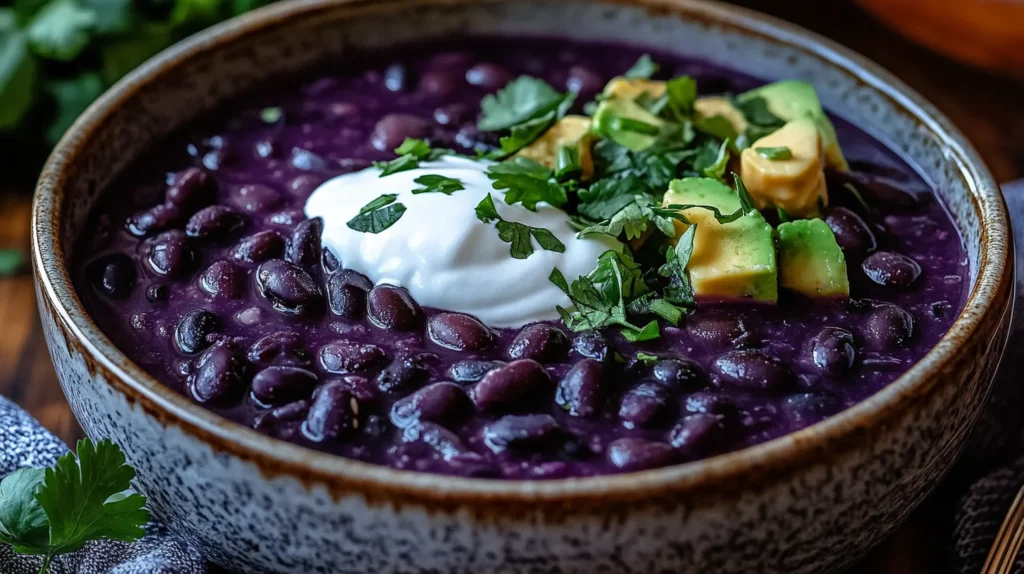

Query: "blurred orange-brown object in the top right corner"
left=857, top=0, right=1024, bottom=78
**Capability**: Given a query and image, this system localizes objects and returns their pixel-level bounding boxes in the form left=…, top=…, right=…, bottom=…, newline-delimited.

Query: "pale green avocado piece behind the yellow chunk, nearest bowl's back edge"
left=736, top=80, right=849, bottom=171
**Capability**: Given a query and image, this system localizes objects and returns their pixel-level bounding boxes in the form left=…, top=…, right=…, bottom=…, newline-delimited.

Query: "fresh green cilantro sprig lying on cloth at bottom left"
left=0, top=439, right=150, bottom=573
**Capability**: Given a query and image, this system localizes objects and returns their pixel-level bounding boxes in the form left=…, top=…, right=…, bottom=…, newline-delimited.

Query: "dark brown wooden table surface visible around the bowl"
left=0, top=0, right=1024, bottom=574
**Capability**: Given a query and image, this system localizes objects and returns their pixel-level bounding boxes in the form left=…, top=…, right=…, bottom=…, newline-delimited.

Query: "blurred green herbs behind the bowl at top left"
left=0, top=0, right=269, bottom=184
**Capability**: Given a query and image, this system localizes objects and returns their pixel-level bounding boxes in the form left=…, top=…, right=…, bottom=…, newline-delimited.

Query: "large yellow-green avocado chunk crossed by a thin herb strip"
left=664, top=177, right=778, bottom=303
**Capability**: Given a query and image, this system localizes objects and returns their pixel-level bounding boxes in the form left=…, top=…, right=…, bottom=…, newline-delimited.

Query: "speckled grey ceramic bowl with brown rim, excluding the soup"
left=33, top=0, right=1013, bottom=574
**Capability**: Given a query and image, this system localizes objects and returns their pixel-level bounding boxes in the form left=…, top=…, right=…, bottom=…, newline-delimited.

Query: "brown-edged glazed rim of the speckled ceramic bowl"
left=32, top=0, right=1012, bottom=503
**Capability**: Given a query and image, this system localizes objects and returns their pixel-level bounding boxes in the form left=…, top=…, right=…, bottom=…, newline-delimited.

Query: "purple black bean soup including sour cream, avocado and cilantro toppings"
left=75, top=38, right=968, bottom=479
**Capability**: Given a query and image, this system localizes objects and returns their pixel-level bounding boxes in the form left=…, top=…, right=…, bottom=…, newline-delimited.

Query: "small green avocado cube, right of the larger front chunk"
left=778, top=219, right=850, bottom=299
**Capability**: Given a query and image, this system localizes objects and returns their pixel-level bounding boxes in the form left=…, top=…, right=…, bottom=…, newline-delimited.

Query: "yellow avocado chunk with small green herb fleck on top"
left=739, top=118, right=828, bottom=218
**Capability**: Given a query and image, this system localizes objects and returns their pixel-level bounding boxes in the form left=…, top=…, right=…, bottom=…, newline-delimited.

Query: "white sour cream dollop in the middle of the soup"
left=305, top=157, right=622, bottom=327
